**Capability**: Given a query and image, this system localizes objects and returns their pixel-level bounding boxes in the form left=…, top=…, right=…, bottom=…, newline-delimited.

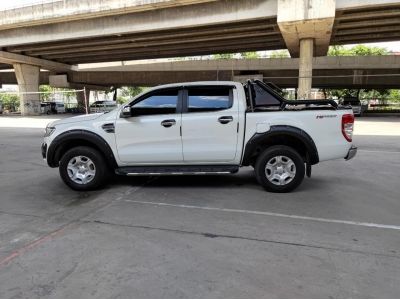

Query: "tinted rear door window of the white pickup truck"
left=188, top=87, right=232, bottom=112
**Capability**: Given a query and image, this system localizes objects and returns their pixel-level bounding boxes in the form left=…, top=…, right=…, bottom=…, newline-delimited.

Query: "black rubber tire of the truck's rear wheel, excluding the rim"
left=254, top=145, right=305, bottom=193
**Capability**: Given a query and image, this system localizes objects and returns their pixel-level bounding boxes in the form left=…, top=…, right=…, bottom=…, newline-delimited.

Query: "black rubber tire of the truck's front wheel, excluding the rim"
left=59, top=146, right=108, bottom=191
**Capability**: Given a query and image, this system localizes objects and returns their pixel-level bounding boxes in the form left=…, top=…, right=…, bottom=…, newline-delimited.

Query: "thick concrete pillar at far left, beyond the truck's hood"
left=14, top=64, right=40, bottom=116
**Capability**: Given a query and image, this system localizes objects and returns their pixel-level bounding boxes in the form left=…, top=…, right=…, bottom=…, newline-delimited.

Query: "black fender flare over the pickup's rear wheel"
left=242, top=125, right=319, bottom=166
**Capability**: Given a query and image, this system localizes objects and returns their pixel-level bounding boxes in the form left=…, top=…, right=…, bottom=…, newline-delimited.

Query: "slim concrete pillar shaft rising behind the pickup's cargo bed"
left=298, top=39, right=314, bottom=99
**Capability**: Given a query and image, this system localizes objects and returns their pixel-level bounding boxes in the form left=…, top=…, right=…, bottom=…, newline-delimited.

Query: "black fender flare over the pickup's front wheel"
left=47, top=129, right=118, bottom=169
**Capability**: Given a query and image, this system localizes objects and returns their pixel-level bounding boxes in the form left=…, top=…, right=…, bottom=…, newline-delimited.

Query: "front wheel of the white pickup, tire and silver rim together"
left=59, top=146, right=107, bottom=191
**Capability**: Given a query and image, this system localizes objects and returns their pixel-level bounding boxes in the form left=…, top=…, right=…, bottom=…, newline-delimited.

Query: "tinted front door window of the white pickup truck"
left=133, top=90, right=178, bottom=115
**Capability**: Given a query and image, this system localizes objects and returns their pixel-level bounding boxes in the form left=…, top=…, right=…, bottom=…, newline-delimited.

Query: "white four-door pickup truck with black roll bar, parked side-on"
left=41, top=80, right=357, bottom=192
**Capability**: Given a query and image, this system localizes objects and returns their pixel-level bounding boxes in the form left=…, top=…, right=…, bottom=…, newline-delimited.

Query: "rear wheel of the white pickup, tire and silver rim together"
left=254, top=145, right=305, bottom=193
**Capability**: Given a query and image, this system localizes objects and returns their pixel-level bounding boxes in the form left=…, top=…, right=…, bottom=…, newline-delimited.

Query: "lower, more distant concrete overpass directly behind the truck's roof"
left=0, top=55, right=400, bottom=89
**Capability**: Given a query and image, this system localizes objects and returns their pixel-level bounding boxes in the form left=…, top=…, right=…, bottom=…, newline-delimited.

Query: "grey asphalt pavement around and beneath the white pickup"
left=0, top=117, right=400, bottom=298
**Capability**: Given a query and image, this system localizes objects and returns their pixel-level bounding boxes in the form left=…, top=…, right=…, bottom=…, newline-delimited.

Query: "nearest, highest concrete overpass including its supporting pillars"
left=0, top=0, right=400, bottom=114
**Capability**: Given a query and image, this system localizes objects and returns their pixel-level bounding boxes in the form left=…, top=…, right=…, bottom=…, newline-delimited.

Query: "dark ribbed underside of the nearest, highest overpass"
left=3, top=3, right=400, bottom=64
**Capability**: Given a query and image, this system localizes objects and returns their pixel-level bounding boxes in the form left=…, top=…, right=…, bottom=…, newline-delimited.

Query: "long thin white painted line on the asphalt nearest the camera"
left=124, top=200, right=400, bottom=230
